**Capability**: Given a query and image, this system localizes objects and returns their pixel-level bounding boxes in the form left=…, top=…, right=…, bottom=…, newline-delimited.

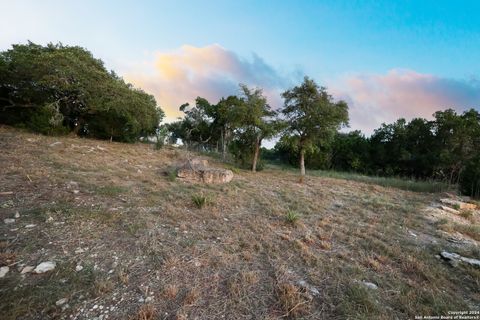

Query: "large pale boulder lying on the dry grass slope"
left=177, top=158, right=233, bottom=183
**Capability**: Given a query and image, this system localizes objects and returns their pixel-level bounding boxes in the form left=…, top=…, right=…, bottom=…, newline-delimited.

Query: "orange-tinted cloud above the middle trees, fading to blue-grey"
left=125, top=44, right=290, bottom=120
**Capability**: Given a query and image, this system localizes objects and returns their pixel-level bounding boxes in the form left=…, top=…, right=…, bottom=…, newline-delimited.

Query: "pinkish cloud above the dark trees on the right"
left=331, top=69, right=480, bottom=134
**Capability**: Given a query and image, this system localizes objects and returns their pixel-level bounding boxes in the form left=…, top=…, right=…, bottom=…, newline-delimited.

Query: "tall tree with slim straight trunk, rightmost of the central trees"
left=281, top=77, right=348, bottom=182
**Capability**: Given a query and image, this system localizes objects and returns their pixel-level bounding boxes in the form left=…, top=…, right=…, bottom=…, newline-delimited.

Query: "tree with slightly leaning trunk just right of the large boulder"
left=231, top=84, right=279, bottom=172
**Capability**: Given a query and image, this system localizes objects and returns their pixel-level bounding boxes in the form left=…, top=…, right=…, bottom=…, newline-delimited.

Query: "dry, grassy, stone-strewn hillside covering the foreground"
left=0, top=127, right=480, bottom=319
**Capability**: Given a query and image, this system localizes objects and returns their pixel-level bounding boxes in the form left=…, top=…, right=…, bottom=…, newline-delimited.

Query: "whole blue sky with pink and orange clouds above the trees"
left=0, top=0, right=480, bottom=135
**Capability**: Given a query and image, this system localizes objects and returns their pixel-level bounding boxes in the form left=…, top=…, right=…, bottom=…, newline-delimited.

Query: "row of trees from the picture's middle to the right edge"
left=166, top=77, right=480, bottom=197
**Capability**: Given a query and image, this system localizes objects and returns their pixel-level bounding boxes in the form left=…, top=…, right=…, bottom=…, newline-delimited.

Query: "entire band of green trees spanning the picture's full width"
left=0, top=42, right=480, bottom=197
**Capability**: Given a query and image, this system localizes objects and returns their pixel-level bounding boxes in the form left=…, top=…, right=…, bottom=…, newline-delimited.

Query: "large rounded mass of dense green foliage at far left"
left=0, top=42, right=163, bottom=141
